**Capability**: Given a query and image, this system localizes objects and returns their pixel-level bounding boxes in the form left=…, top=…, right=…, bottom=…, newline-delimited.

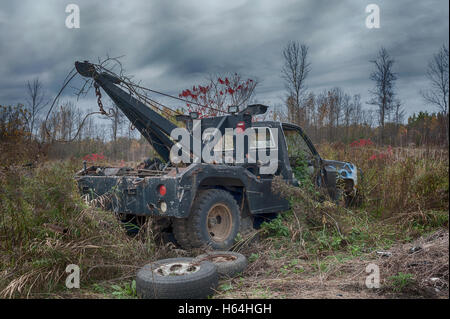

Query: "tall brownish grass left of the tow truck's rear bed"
left=0, top=162, right=156, bottom=297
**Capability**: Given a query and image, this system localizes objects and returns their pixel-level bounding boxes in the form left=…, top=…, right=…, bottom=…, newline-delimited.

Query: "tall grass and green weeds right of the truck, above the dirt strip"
left=263, top=144, right=449, bottom=255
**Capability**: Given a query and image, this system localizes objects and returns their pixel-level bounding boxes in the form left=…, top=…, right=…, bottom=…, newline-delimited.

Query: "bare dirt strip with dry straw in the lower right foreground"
left=215, top=230, right=448, bottom=299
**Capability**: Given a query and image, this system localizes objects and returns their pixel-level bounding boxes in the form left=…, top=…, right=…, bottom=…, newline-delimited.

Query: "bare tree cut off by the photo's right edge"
left=421, top=45, right=449, bottom=145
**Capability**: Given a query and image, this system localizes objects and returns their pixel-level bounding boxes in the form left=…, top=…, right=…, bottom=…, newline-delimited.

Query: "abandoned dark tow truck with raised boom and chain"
left=75, top=61, right=358, bottom=250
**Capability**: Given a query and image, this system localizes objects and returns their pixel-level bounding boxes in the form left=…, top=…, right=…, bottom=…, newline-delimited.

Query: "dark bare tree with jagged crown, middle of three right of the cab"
left=368, top=47, right=397, bottom=142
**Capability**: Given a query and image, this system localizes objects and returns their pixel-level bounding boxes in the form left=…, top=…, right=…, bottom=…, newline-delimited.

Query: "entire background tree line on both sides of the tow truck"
left=0, top=41, right=449, bottom=166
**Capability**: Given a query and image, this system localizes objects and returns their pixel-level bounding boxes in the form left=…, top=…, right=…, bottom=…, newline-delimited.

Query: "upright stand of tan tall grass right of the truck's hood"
left=320, top=145, right=449, bottom=223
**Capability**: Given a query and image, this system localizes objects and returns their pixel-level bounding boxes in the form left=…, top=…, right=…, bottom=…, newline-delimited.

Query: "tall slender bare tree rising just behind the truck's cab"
left=281, top=41, right=311, bottom=126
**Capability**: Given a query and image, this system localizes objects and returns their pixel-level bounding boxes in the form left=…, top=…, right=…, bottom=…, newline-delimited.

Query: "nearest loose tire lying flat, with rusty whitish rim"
left=136, top=258, right=218, bottom=299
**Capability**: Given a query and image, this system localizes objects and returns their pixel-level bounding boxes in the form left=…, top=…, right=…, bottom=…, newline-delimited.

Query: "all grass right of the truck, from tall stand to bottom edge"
left=213, top=145, right=448, bottom=298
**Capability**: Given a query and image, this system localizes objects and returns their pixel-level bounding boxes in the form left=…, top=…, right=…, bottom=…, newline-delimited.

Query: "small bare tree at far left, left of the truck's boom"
left=26, top=78, right=48, bottom=138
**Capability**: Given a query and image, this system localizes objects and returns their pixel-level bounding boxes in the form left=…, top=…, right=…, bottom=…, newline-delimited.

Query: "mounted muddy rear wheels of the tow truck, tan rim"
left=172, top=189, right=241, bottom=250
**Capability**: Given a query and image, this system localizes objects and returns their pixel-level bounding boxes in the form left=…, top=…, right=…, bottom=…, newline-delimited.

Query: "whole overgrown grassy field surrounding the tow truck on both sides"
left=0, top=143, right=449, bottom=298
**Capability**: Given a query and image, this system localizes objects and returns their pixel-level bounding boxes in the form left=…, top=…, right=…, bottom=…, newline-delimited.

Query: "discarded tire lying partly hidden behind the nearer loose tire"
left=195, top=251, right=247, bottom=277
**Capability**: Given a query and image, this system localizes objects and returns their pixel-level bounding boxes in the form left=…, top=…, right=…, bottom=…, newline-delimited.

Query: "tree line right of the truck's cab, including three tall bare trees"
left=280, top=42, right=449, bottom=147
